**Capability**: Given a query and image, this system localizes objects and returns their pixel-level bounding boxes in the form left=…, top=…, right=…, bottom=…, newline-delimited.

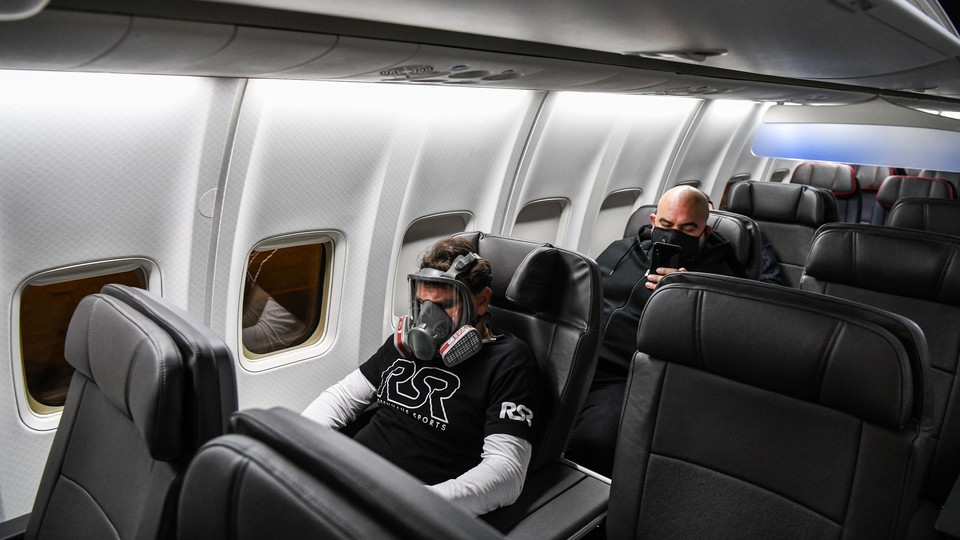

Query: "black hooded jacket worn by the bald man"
left=594, top=225, right=745, bottom=382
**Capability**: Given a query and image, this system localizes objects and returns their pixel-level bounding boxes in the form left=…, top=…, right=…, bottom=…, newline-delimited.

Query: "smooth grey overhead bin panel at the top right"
left=199, top=0, right=960, bottom=95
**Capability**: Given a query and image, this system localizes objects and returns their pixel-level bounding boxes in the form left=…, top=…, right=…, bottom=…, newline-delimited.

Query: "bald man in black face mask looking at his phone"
left=566, top=186, right=745, bottom=477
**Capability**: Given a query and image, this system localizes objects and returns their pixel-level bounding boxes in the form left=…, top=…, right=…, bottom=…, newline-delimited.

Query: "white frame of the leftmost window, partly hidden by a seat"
left=10, top=257, right=162, bottom=431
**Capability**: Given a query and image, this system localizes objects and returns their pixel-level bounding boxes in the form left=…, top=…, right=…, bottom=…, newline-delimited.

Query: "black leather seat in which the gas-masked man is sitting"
left=459, top=232, right=609, bottom=531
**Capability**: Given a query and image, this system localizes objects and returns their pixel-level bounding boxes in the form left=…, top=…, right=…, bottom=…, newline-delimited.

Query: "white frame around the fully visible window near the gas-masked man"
left=235, top=231, right=346, bottom=373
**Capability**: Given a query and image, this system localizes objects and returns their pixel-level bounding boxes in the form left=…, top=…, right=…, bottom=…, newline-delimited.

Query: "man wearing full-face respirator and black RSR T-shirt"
left=303, top=238, right=539, bottom=514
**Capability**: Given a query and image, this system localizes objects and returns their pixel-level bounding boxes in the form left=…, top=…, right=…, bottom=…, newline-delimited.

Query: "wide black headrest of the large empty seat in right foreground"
left=637, top=272, right=929, bottom=428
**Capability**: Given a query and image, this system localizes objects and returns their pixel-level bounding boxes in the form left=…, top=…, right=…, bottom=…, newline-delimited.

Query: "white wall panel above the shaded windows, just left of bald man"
left=504, top=93, right=700, bottom=252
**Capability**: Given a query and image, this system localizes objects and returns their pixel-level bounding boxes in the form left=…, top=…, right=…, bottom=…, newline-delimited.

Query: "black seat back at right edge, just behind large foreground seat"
left=801, top=224, right=960, bottom=503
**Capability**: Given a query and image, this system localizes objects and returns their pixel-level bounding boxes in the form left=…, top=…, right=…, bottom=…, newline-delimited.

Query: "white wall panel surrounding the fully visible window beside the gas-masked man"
left=210, top=81, right=539, bottom=410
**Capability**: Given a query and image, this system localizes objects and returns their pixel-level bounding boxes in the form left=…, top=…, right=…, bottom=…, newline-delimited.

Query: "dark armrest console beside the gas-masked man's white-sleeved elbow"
left=481, top=460, right=610, bottom=540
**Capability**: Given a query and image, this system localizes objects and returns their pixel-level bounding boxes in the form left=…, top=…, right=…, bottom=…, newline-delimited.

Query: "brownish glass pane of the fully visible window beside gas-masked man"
left=241, top=239, right=334, bottom=359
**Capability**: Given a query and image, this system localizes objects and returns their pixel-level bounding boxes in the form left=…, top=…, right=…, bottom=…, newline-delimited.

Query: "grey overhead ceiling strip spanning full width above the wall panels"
left=0, top=0, right=960, bottom=108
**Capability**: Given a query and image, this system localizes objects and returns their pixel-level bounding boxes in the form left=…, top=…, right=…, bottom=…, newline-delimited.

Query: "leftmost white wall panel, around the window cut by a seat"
left=0, top=72, right=235, bottom=520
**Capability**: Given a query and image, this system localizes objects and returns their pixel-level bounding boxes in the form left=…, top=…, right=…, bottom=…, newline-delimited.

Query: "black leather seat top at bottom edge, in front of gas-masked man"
left=177, top=408, right=502, bottom=540
